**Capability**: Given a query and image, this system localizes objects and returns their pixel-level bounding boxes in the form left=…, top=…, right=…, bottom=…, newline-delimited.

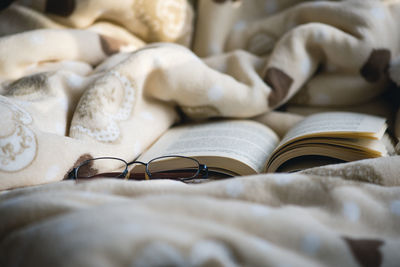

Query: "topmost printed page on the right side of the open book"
left=281, top=112, right=386, bottom=148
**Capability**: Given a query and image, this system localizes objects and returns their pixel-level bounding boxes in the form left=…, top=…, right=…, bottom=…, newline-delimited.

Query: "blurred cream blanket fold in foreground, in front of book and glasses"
left=0, top=161, right=400, bottom=266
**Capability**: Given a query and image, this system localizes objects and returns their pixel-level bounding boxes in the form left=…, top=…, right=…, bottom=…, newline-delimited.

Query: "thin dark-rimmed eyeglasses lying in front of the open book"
left=68, top=155, right=208, bottom=181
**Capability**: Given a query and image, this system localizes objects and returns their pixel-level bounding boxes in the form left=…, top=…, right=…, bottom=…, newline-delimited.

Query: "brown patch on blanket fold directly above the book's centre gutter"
left=264, top=68, right=293, bottom=108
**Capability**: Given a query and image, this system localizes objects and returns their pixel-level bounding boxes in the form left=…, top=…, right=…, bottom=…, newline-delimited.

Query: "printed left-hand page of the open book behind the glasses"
left=140, top=120, right=279, bottom=172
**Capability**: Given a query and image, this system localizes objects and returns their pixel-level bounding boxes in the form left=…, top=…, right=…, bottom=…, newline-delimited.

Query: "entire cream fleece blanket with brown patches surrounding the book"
left=0, top=0, right=400, bottom=266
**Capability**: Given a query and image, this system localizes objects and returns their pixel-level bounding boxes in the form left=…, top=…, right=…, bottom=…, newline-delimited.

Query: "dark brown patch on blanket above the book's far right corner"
left=360, top=49, right=390, bottom=83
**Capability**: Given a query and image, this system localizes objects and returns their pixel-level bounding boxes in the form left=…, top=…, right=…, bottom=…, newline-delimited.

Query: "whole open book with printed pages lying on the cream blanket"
left=139, top=112, right=390, bottom=176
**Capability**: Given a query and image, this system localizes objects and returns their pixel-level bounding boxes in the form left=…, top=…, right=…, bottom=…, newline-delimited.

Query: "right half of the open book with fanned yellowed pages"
left=266, top=112, right=387, bottom=172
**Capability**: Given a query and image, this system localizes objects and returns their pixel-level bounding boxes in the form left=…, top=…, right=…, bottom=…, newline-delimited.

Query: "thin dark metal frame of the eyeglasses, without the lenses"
left=68, top=155, right=209, bottom=181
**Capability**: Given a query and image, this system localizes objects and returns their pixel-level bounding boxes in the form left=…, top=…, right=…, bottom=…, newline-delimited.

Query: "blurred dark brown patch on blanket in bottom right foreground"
left=343, top=237, right=383, bottom=267
